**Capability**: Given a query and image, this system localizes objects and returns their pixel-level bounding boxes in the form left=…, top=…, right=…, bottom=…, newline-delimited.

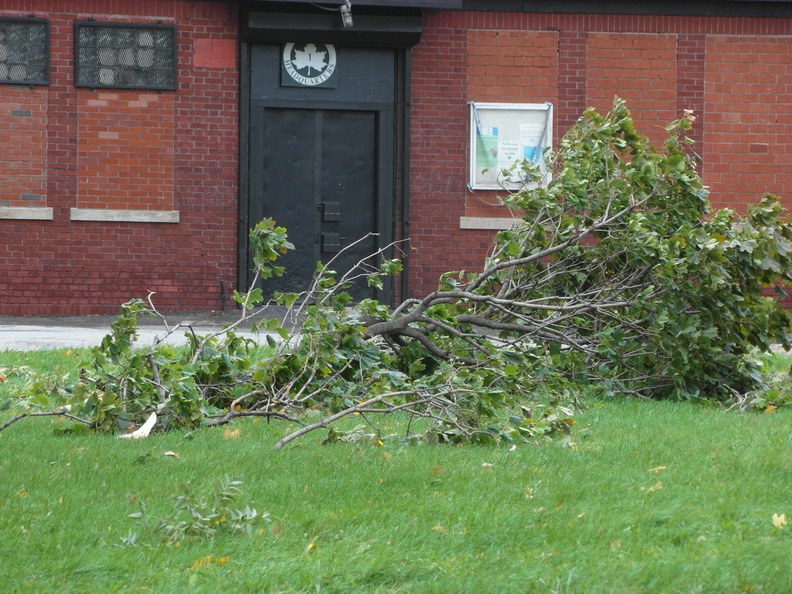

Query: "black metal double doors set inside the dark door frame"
left=250, top=107, right=382, bottom=299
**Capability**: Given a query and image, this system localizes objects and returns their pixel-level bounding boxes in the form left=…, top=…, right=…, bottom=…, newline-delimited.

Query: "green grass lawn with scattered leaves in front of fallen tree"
left=0, top=353, right=792, bottom=593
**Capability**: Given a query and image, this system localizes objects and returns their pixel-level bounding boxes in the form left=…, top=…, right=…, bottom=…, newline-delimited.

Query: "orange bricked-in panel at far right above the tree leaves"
left=704, top=35, right=792, bottom=210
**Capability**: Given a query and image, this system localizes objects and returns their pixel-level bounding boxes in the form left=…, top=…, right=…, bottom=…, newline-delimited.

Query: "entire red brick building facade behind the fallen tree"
left=0, top=0, right=792, bottom=315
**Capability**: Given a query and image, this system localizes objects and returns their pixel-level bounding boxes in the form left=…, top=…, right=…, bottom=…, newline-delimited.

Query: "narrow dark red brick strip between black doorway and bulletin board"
left=408, top=13, right=480, bottom=294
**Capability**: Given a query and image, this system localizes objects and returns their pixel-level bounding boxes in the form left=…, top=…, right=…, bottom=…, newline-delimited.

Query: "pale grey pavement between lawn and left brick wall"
left=0, top=307, right=285, bottom=352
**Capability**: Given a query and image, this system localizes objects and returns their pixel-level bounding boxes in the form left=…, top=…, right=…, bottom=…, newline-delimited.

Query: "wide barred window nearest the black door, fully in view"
left=74, top=22, right=176, bottom=90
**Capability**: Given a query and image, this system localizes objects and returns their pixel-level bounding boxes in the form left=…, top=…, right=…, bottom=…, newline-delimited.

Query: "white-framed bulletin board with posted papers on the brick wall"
left=469, top=102, right=553, bottom=190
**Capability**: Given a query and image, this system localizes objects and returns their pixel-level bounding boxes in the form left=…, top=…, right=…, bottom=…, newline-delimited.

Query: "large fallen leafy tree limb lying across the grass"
left=1, top=100, right=792, bottom=448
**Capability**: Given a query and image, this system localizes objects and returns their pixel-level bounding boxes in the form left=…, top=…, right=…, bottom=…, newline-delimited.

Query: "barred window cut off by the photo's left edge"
left=0, top=19, right=49, bottom=85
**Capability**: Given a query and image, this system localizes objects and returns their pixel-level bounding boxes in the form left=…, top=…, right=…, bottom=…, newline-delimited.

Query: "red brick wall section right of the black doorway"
left=410, top=12, right=792, bottom=296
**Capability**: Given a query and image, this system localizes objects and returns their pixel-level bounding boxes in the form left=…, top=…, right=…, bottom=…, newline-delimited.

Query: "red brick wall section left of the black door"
left=0, top=0, right=239, bottom=315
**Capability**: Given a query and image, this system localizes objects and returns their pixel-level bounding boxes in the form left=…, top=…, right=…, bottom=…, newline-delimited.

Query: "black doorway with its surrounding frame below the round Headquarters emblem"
left=239, top=44, right=406, bottom=302
